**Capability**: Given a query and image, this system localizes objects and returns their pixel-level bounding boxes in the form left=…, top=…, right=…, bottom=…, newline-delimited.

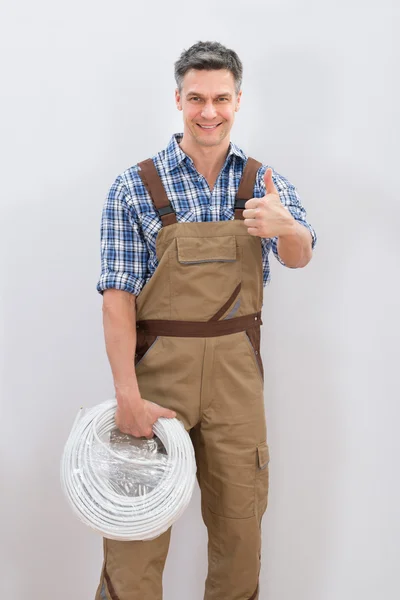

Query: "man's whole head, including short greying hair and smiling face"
left=175, top=42, right=243, bottom=146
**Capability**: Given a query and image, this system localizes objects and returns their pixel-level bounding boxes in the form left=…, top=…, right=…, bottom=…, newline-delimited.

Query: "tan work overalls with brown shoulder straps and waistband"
left=96, top=159, right=269, bottom=600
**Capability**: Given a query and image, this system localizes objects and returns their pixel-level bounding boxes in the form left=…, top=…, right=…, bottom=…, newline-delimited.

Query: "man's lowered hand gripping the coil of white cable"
left=115, top=398, right=176, bottom=439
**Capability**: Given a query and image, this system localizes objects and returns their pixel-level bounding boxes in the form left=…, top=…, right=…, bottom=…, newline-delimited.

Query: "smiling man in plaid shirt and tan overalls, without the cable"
left=96, top=42, right=316, bottom=600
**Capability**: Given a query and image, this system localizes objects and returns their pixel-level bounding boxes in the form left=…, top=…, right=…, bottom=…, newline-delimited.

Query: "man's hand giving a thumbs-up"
left=243, top=169, right=296, bottom=238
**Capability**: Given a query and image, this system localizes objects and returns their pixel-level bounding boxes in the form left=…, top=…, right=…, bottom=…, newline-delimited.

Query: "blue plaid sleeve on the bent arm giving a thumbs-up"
left=255, top=166, right=317, bottom=266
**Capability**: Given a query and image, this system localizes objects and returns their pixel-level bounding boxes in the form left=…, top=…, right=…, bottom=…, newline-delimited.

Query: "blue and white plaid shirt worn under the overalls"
left=97, top=134, right=316, bottom=295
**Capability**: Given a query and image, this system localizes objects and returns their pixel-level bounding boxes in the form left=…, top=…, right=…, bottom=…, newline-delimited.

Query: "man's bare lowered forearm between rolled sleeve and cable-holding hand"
left=103, top=290, right=141, bottom=402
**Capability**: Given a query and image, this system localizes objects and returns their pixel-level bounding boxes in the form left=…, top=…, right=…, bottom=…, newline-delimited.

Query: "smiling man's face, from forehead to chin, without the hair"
left=175, top=69, right=242, bottom=147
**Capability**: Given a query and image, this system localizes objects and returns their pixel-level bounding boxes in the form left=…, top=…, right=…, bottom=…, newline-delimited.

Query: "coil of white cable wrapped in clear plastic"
left=61, top=400, right=196, bottom=540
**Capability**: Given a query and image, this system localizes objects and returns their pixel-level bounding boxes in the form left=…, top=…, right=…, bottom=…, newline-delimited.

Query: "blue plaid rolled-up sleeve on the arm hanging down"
left=97, top=176, right=149, bottom=295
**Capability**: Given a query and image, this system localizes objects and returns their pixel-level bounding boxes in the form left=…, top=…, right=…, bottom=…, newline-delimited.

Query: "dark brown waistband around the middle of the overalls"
left=136, top=312, right=262, bottom=337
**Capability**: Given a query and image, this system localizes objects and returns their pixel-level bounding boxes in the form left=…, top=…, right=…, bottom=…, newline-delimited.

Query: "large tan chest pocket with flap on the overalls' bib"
left=169, top=235, right=241, bottom=321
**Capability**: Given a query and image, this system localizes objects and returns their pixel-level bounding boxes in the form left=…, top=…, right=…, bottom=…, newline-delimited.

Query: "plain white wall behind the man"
left=0, top=0, right=400, bottom=600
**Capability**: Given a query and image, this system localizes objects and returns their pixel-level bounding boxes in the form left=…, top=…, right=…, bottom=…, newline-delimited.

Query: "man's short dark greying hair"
left=175, top=42, right=243, bottom=94
